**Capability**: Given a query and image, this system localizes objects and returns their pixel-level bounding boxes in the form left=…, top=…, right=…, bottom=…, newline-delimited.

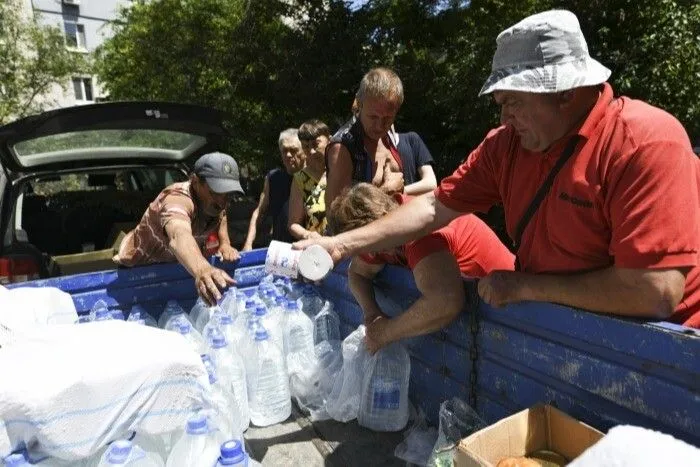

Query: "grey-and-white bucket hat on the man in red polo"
left=479, top=10, right=610, bottom=96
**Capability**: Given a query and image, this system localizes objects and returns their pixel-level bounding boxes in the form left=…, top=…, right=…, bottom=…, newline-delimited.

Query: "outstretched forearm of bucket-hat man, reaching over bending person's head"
left=335, top=193, right=459, bottom=257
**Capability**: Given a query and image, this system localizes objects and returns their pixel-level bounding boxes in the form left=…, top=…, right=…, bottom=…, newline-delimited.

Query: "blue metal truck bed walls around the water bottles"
left=14, top=250, right=700, bottom=452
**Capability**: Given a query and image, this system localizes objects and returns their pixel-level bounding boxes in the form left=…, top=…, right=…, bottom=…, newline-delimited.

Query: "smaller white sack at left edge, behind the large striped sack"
left=0, top=285, right=78, bottom=347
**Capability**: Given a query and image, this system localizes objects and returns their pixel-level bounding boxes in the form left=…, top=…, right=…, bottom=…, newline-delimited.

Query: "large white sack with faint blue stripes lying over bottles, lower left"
left=0, top=320, right=209, bottom=460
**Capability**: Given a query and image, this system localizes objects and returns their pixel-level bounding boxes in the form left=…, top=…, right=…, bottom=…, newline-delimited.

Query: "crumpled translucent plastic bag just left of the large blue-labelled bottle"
left=326, top=325, right=369, bottom=423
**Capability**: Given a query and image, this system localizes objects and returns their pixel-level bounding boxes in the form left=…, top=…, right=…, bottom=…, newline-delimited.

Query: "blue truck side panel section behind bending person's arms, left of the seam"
left=321, top=262, right=471, bottom=424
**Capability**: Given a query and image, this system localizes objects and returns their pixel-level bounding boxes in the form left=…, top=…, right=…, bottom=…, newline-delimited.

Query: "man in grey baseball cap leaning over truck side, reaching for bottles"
left=113, top=152, right=243, bottom=304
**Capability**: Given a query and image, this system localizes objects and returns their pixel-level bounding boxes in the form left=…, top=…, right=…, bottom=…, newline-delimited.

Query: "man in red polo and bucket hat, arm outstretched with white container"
left=296, top=10, right=700, bottom=328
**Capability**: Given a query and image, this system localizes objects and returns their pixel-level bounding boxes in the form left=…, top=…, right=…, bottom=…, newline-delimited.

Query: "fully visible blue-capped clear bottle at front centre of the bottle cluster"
left=248, top=329, right=292, bottom=426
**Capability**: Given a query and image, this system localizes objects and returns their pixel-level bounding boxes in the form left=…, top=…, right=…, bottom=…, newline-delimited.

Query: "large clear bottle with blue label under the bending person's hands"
left=357, top=343, right=411, bottom=431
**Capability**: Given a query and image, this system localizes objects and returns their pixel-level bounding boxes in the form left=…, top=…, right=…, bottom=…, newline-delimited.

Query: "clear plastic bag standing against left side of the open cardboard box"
left=428, top=397, right=487, bottom=467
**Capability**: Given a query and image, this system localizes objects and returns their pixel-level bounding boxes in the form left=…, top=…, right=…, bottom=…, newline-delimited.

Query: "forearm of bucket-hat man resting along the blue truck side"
left=518, top=266, right=685, bottom=319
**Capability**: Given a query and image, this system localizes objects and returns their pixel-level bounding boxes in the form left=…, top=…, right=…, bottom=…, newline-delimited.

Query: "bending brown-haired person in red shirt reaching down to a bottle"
left=327, top=183, right=515, bottom=353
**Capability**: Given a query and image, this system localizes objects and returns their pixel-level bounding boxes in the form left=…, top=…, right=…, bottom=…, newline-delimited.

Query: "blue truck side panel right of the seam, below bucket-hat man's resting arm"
left=477, top=303, right=700, bottom=445
